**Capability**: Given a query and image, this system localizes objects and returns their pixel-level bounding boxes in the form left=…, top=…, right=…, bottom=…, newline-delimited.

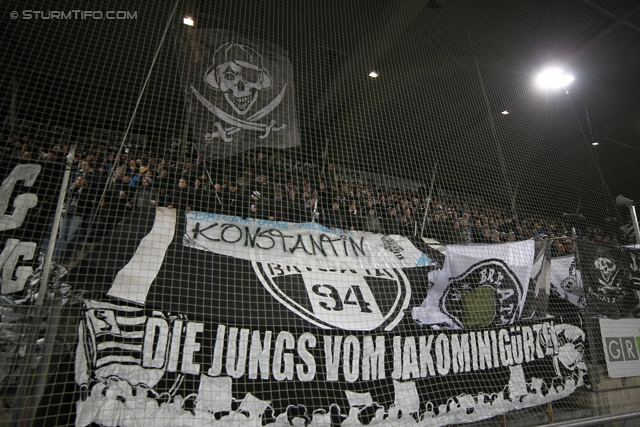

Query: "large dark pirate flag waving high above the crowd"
left=180, top=29, right=300, bottom=158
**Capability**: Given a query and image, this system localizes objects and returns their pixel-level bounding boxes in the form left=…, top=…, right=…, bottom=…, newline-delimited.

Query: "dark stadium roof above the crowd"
left=0, top=0, right=640, bottom=217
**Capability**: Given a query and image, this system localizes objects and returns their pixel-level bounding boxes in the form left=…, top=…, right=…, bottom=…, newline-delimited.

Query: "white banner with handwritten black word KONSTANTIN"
left=184, top=212, right=433, bottom=270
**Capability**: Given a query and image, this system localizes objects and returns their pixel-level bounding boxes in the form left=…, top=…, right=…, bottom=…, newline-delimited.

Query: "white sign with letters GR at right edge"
left=600, top=319, right=640, bottom=378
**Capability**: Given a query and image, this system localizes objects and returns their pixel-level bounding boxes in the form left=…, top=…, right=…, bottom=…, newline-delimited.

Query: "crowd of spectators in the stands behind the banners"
left=0, top=130, right=633, bottom=259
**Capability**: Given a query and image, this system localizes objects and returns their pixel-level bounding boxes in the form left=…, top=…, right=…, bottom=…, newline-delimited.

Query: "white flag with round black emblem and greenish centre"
left=412, top=240, right=535, bottom=329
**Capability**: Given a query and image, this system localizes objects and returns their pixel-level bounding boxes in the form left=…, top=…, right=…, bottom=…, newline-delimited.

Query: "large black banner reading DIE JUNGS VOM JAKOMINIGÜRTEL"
left=67, top=210, right=586, bottom=426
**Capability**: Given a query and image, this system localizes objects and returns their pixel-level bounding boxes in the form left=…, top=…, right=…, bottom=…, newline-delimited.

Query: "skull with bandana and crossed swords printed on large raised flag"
left=191, top=43, right=287, bottom=142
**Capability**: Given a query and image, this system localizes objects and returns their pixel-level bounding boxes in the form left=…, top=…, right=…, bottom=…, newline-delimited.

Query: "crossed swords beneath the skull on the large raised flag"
left=190, top=83, right=287, bottom=142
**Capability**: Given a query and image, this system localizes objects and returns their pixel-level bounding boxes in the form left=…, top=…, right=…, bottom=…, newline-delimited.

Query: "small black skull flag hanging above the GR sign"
left=577, top=240, right=637, bottom=318
